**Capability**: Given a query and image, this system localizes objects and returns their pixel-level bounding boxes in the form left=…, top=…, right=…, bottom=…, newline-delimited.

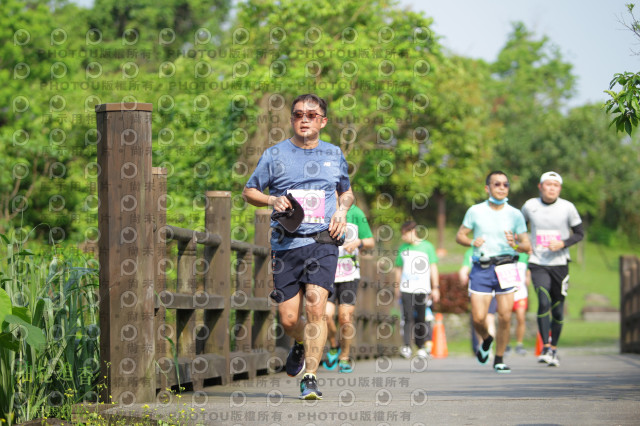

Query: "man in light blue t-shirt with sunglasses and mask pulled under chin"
left=456, top=171, right=531, bottom=373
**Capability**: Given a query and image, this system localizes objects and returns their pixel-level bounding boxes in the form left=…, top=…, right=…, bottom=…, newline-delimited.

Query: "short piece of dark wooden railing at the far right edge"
left=620, top=256, right=640, bottom=353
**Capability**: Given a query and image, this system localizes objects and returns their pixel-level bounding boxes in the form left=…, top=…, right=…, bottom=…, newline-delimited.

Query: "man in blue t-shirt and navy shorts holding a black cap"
left=242, top=94, right=353, bottom=399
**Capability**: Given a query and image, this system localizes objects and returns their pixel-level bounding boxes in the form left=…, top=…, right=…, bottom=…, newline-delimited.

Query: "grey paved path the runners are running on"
left=109, top=353, right=640, bottom=425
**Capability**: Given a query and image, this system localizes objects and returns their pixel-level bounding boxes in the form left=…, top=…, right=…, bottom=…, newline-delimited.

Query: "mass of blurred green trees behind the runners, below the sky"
left=0, top=0, right=640, bottom=248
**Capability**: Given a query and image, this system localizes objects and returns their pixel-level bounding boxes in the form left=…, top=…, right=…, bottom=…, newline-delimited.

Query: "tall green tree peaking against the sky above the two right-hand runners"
left=491, top=23, right=575, bottom=198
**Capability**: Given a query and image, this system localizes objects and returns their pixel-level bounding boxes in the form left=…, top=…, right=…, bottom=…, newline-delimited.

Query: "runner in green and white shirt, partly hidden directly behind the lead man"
left=322, top=204, right=375, bottom=373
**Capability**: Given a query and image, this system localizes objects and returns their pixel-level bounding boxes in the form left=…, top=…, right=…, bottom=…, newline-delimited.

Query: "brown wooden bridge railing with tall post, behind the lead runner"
left=96, top=103, right=400, bottom=405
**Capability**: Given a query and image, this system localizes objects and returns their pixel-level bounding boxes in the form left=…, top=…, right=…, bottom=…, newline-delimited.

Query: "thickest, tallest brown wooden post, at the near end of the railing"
left=96, top=103, right=156, bottom=405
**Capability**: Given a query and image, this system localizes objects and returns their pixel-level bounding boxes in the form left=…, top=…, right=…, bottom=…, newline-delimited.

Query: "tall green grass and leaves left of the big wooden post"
left=0, top=228, right=100, bottom=425
